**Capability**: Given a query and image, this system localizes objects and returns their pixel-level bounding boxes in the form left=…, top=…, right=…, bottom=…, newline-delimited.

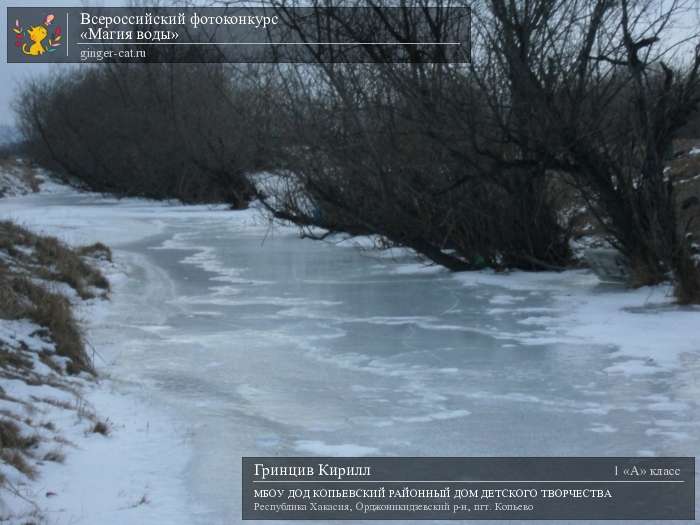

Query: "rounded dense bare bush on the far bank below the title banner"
left=16, top=64, right=265, bottom=207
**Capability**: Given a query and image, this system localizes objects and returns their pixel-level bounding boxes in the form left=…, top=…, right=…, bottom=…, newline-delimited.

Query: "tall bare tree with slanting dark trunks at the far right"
left=464, top=0, right=700, bottom=302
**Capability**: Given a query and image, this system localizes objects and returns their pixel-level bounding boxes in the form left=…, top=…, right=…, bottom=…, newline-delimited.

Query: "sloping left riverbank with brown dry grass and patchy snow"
left=0, top=221, right=110, bottom=520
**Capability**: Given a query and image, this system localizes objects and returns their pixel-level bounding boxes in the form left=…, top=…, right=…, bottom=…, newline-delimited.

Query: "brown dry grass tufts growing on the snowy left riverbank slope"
left=0, top=217, right=111, bottom=508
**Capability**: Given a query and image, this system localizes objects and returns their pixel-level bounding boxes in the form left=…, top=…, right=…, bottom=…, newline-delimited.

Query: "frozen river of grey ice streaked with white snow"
left=2, top=187, right=700, bottom=524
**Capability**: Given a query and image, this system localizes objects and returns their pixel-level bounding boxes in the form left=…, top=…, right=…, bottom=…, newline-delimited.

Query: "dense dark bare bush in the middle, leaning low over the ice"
left=260, top=1, right=569, bottom=270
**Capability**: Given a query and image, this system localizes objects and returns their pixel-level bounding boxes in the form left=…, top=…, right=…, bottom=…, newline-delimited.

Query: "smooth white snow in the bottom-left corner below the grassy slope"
left=0, top=321, right=189, bottom=525
